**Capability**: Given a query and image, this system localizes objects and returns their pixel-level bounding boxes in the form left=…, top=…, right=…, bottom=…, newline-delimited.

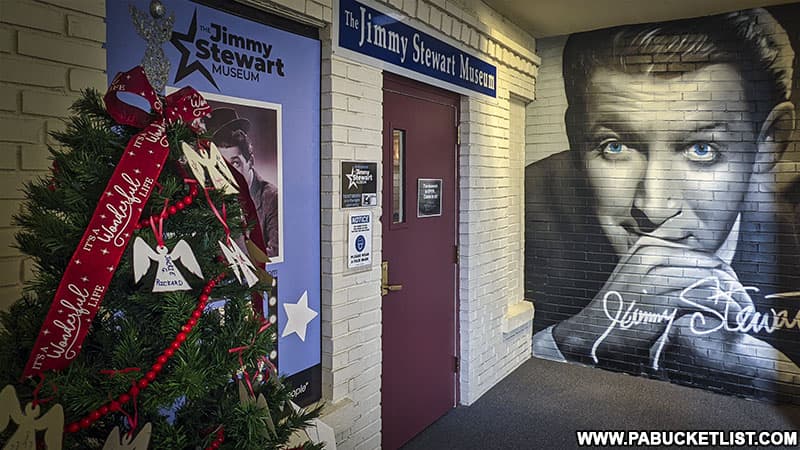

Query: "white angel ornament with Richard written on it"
left=133, top=236, right=203, bottom=292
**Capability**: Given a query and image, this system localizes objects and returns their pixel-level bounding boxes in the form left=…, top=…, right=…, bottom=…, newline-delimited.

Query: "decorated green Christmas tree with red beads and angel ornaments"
left=0, top=69, right=318, bottom=449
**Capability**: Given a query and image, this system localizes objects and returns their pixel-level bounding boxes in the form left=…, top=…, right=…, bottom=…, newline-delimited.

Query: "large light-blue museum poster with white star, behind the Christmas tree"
left=107, top=0, right=321, bottom=403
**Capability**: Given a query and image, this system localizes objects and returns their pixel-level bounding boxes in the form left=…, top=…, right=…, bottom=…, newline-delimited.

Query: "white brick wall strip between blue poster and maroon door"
left=321, top=32, right=383, bottom=448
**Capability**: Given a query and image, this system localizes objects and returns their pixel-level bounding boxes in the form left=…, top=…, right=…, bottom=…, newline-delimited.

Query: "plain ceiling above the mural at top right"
left=483, top=0, right=796, bottom=38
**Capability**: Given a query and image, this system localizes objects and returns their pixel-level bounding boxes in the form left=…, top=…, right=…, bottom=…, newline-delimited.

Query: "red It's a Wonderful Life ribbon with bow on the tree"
left=23, top=67, right=211, bottom=377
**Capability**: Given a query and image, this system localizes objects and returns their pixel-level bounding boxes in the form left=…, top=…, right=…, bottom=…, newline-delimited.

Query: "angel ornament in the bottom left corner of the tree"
left=0, top=384, right=64, bottom=450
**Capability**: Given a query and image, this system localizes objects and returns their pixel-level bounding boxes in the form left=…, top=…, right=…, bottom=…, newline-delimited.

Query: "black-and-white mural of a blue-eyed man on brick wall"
left=525, top=4, right=800, bottom=403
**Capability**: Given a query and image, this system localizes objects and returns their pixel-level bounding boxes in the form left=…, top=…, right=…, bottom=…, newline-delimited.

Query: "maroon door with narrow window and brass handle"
left=381, top=74, right=459, bottom=450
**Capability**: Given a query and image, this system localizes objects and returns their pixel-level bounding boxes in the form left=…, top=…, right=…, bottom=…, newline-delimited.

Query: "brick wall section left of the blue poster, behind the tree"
left=0, top=0, right=106, bottom=310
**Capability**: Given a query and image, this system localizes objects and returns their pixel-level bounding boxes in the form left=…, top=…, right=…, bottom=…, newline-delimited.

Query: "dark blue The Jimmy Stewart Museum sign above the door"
left=336, top=0, right=497, bottom=97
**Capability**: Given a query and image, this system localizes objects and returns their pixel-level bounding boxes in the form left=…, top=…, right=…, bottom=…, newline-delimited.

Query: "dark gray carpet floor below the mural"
left=403, top=358, right=800, bottom=450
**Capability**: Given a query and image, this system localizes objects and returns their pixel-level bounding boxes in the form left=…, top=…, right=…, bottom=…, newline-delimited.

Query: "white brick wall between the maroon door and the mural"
left=459, top=61, right=534, bottom=405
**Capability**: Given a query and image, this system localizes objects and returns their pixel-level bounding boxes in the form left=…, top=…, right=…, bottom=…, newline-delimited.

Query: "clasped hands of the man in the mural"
left=553, top=235, right=753, bottom=369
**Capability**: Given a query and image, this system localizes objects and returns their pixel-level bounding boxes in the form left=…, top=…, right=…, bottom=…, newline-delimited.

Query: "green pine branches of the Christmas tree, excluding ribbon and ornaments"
left=0, top=90, right=319, bottom=449
